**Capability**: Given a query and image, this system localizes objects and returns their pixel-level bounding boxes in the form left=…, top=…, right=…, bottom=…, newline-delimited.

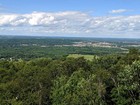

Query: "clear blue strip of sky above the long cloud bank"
left=0, top=0, right=140, bottom=16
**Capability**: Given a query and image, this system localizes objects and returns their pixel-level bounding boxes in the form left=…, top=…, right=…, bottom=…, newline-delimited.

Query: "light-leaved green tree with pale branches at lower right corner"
left=112, top=61, right=140, bottom=105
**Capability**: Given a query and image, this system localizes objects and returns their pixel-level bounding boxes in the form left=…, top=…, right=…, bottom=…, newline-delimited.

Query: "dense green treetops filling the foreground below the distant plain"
left=0, top=49, right=140, bottom=105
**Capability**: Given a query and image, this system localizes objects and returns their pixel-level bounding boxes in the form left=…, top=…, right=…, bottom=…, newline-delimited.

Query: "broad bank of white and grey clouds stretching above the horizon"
left=0, top=11, right=140, bottom=36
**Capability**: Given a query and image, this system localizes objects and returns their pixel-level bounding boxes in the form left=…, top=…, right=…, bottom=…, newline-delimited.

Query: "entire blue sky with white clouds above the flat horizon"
left=0, top=0, right=140, bottom=38
